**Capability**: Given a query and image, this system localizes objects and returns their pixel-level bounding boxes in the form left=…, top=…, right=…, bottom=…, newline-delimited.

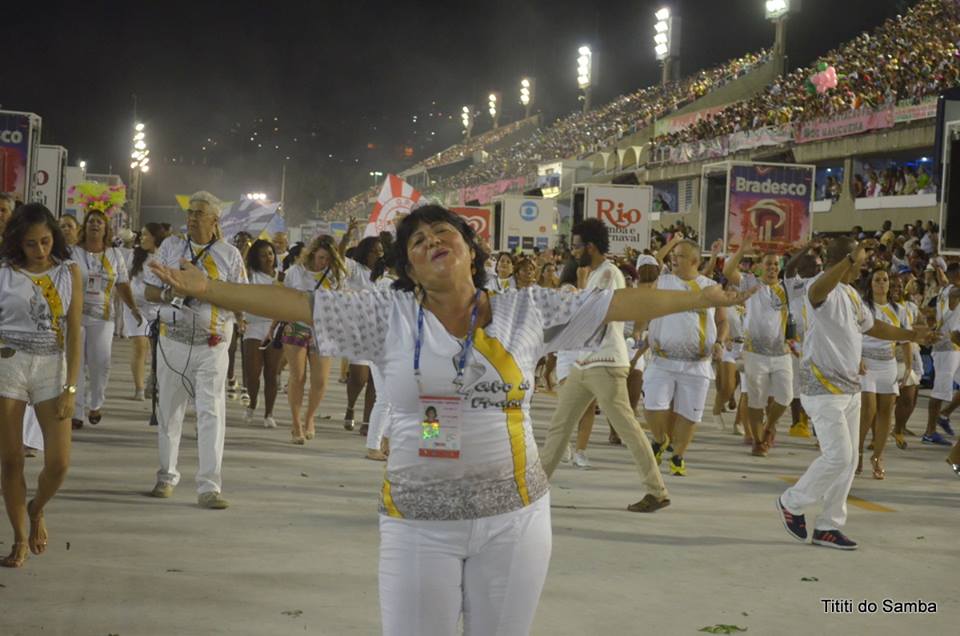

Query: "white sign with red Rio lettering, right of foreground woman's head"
left=584, top=185, right=653, bottom=254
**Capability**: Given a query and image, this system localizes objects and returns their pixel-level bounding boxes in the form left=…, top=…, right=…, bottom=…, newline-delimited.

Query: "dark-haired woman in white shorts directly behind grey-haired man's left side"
left=123, top=223, right=167, bottom=400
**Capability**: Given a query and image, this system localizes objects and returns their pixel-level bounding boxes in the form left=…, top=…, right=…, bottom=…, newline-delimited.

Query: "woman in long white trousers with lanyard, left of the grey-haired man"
left=73, top=210, right=143, bottom=428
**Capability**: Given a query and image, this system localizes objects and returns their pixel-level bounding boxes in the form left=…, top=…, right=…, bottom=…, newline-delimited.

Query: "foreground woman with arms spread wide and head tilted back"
left=152, top=205, right=748, bottom=636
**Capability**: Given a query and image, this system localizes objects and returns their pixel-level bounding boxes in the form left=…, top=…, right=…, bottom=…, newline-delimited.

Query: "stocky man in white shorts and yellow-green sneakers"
left=643, top=239, right=727, bottom=476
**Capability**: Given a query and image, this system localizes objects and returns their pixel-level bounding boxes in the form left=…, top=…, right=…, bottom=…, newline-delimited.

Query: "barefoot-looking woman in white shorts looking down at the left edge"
left=0, top=203, right=83, bottom=568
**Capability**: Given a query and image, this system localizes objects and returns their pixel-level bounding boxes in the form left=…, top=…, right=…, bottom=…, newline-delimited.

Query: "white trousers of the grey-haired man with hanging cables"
left=157, top=336, right=230, bottom=494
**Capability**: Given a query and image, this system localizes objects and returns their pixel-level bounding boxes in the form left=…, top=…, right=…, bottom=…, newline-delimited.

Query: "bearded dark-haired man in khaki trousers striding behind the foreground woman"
left=540, top=219, right=670, bottom=512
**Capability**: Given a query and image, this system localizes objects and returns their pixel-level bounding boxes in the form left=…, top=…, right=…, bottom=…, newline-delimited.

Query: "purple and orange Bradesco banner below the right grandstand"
left=726, top=163, right=814, bottom=253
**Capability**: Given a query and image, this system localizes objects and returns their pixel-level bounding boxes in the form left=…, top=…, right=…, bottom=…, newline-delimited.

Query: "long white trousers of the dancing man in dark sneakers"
left=781, top=393, right=860, bottom=530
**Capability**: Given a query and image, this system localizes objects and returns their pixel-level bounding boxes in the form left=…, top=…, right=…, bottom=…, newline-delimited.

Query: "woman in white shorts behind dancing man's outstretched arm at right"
left=857, top=269, right=913, bottom=479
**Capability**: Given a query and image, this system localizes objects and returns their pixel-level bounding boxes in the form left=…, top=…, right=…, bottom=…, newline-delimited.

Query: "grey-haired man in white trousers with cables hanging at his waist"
left=144, top=191, right=247, bottom=509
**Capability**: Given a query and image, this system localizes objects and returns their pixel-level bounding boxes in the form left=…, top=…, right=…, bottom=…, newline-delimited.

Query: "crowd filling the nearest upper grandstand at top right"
left=653, top=0, right=960, bottom=146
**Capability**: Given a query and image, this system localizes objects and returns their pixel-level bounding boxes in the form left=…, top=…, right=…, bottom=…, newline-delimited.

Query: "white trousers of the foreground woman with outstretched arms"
left=380, top=493, right=551, bottom=636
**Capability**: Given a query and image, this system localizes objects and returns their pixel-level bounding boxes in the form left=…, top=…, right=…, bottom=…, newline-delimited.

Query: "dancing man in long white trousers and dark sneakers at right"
left=777, top=236, right=929, bottom=550
